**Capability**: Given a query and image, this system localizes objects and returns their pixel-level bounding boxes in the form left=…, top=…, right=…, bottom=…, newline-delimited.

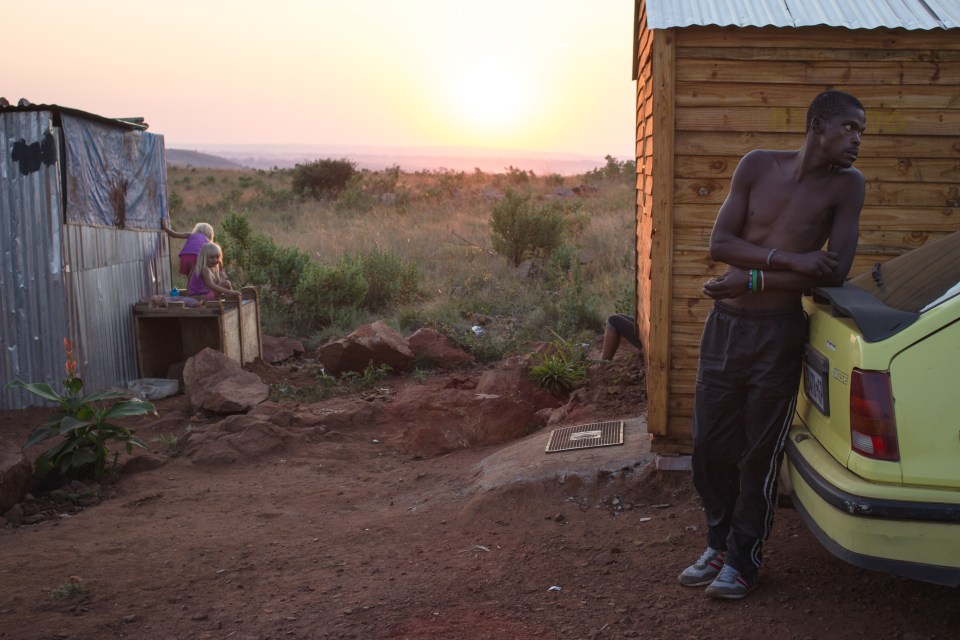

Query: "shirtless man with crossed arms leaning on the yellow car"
left=678, top=91, right=866, bottom=599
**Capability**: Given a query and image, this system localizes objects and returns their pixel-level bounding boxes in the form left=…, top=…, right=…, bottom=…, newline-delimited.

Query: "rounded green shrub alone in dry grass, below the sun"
left=490, top=189, right=565, bottom=266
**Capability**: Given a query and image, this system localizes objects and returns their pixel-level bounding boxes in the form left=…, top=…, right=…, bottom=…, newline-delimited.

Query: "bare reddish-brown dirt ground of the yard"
left=0, top=349, right=960, bottom=640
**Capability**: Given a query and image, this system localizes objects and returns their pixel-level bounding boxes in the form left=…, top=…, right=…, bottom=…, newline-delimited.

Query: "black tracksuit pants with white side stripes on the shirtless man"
left=693, top=301, right=807, bottom=579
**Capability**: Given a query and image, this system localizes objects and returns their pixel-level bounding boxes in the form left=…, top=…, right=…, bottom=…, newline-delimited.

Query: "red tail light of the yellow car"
left=850, top=369, right=900, bottom=460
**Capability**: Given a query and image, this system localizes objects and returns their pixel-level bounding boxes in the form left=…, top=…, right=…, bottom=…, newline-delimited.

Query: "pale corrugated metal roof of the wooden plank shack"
left=646, top=0, right=960, bottom=31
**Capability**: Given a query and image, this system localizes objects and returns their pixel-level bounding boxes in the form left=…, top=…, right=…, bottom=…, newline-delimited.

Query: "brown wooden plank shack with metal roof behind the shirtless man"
left=634, top=0, right=960, bottom=454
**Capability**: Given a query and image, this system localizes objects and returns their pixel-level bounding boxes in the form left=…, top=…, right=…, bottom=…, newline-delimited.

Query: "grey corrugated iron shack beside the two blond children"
left=0, top=100, right=171, bottom=409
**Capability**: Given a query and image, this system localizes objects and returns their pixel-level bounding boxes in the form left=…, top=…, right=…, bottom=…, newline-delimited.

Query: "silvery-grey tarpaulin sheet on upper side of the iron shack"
left=61, top=114, right=167, bottom=229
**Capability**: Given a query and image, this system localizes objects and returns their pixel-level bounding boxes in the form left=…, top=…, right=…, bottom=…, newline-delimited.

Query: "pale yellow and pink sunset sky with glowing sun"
left=7, top=0, right=635, bottom=158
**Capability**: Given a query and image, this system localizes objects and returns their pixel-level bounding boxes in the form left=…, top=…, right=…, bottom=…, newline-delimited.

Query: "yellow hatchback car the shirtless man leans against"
left=783, top=232, right=960, bottom=587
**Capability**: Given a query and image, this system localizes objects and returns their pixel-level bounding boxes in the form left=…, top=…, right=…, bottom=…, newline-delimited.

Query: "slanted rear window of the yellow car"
left=850, top=231, right=960, bottom=313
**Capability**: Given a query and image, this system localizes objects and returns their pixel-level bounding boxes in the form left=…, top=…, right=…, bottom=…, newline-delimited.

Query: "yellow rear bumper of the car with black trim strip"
left=785, top=424, right=960, bottom=587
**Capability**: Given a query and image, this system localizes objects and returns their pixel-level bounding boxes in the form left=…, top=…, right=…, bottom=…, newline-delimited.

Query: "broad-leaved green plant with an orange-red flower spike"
left=7, top=338, right=156, bottom=481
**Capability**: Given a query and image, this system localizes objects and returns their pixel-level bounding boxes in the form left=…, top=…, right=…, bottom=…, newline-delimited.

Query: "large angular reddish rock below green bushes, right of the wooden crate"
left=317, top=320, right=413, bottom=376
